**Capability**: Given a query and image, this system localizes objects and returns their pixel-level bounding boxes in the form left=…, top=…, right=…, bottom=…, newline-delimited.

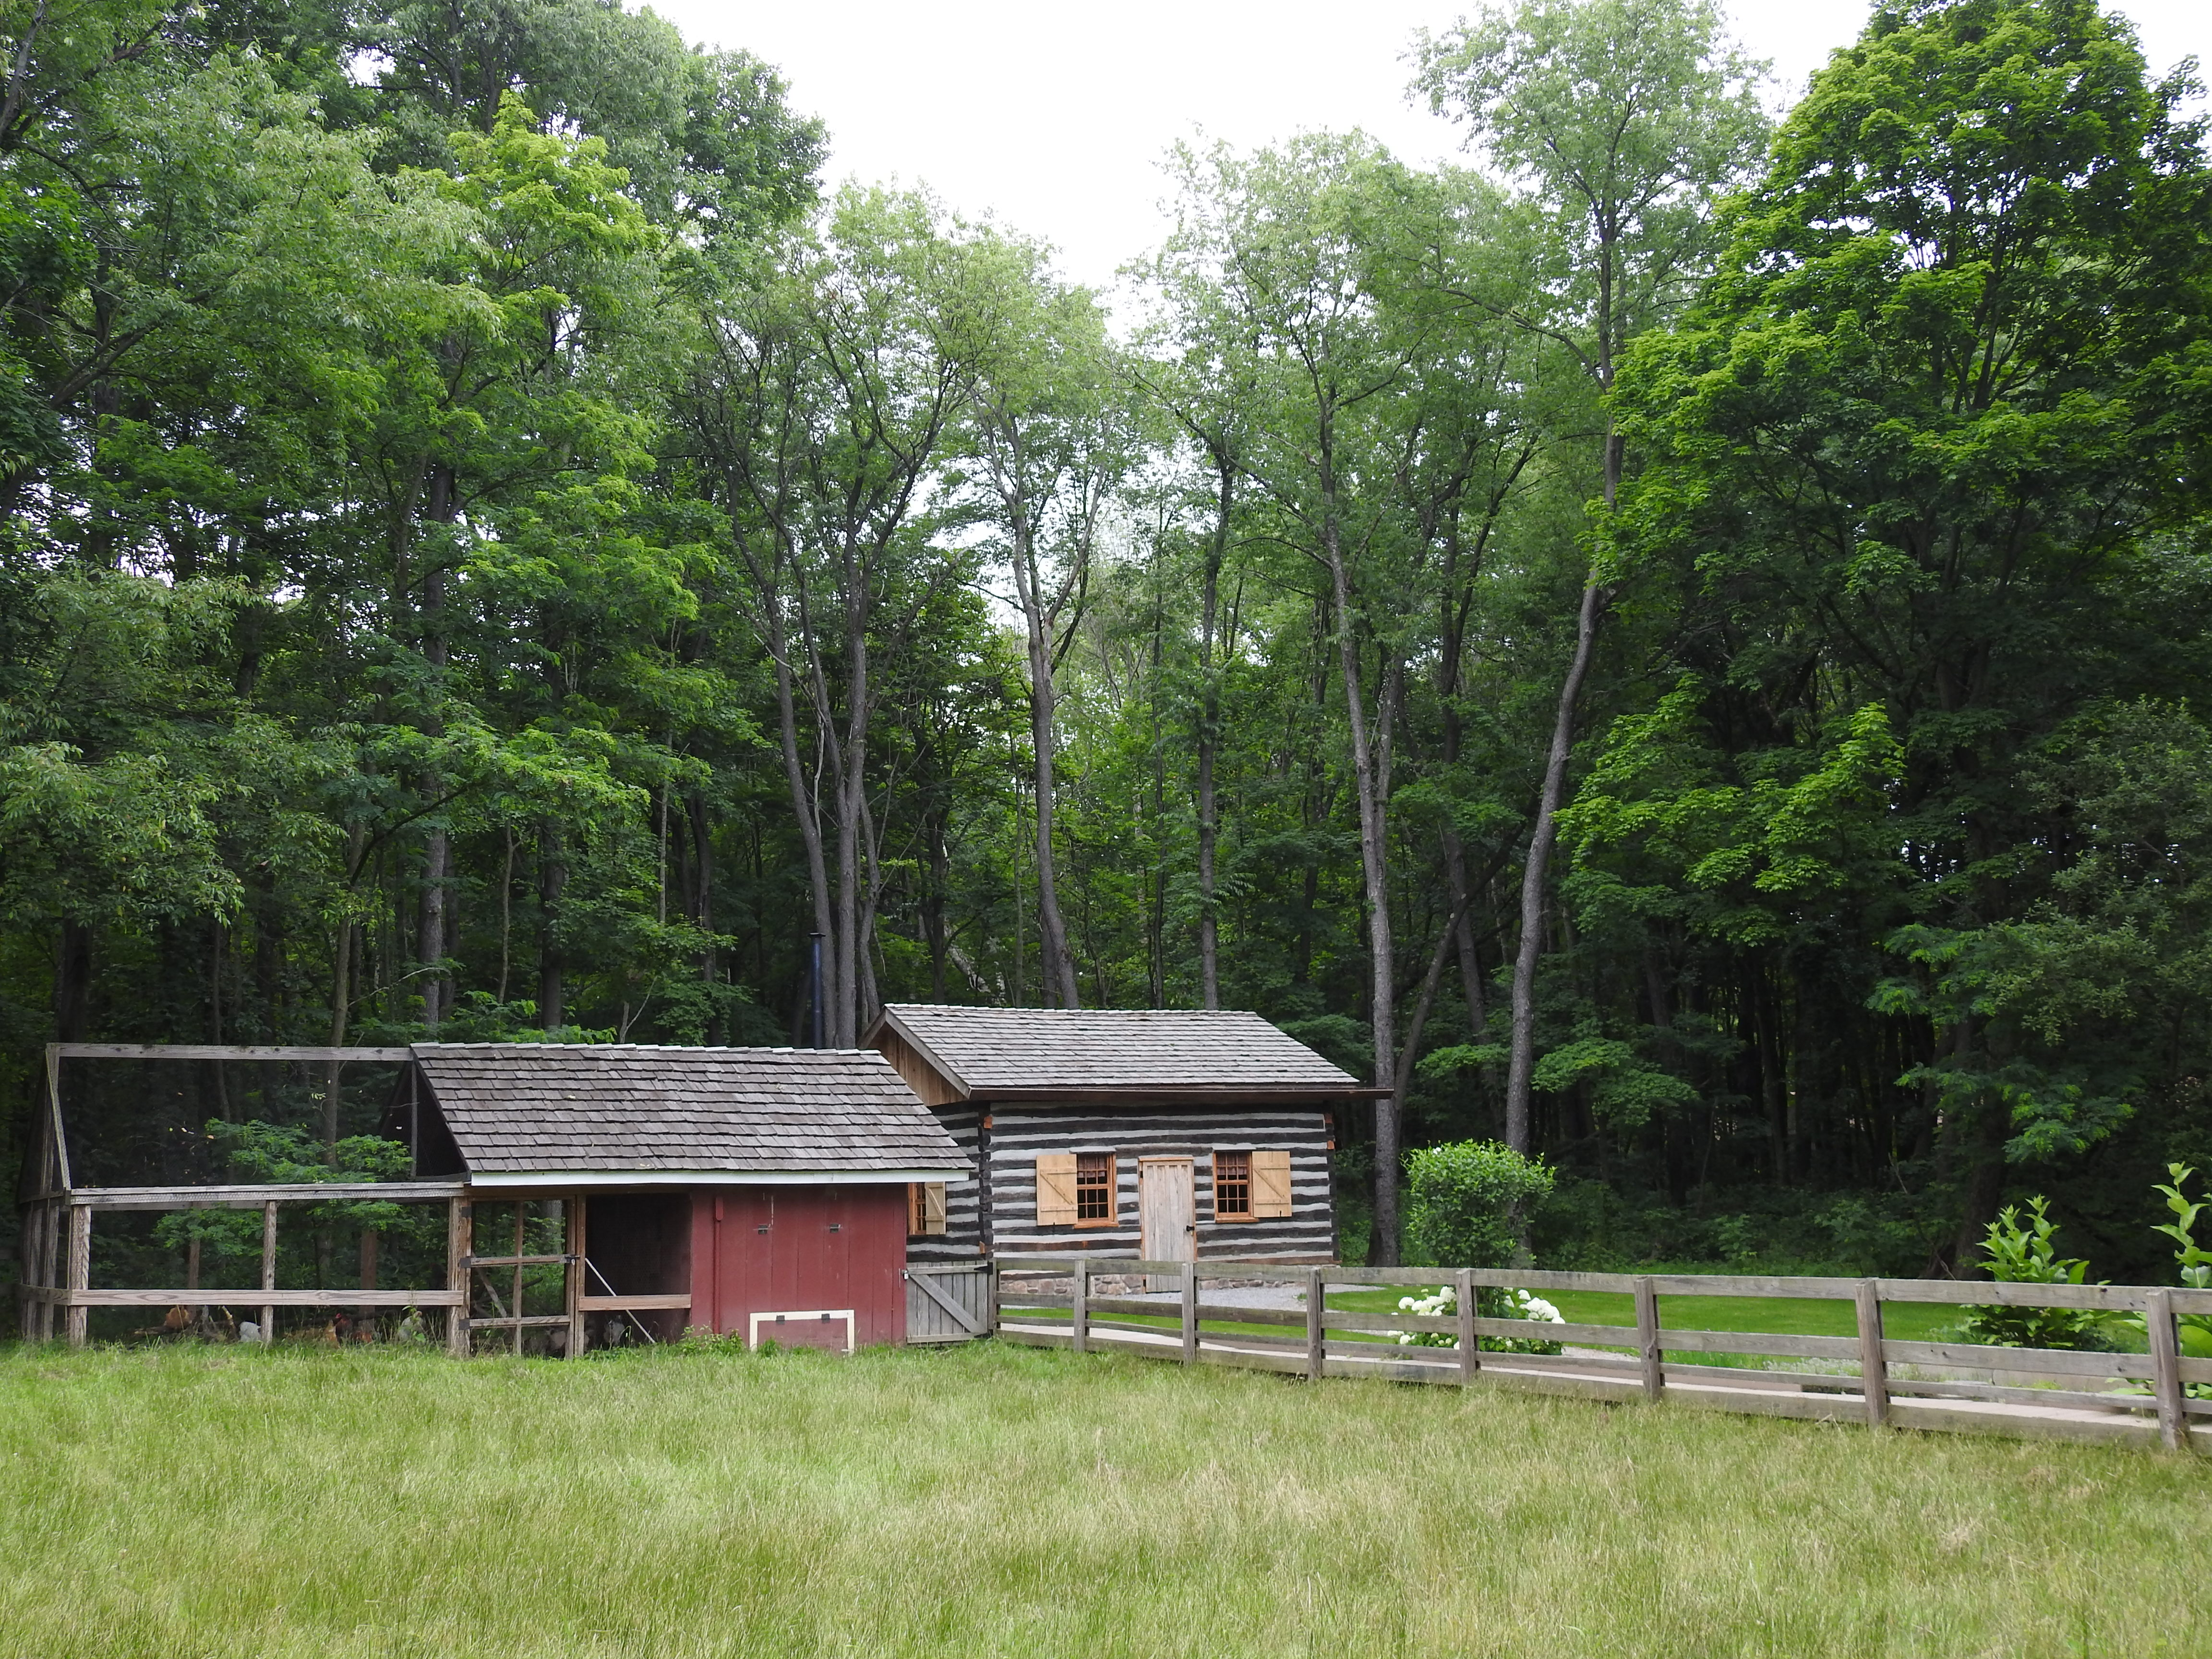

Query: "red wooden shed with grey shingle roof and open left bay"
left=405, top=1044, right=971, bottom=1351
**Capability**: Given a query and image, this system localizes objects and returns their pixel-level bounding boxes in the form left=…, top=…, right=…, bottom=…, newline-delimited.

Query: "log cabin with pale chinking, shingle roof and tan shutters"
left=869, top=1002, right=1374, bottom=1263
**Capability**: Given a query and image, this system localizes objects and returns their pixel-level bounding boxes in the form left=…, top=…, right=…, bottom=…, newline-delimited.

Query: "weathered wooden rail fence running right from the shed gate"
left=993, top=1254, right=2212, bottom=1451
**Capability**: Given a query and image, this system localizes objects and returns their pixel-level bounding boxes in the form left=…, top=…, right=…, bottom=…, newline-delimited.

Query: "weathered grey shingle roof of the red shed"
left=414, top=1042, right=969, bottom=1179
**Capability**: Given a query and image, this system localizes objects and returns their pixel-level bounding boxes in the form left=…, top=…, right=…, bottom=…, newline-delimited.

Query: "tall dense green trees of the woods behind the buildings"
left=0, top=0, right=2212, bottom=1270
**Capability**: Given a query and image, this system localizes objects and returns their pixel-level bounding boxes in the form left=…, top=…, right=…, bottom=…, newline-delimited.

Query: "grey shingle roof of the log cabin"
left=883, top=1002, right=1358, bottom=1099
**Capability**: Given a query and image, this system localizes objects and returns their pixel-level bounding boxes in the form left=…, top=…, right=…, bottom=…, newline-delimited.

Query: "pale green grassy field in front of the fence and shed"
left=0, top=1345, right=2212, bottom=1659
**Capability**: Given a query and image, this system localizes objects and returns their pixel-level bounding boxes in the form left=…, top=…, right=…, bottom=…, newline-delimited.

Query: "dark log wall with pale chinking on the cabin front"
left=907, top=1106, right=1336, bottom=1261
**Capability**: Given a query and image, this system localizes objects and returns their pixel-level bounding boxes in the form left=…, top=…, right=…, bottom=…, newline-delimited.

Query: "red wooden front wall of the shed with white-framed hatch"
left=692, top=1186, right=907, bottom=1349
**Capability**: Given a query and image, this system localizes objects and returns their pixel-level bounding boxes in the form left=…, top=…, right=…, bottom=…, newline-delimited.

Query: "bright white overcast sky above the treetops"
left=652, top=0, right=2212, bottom=288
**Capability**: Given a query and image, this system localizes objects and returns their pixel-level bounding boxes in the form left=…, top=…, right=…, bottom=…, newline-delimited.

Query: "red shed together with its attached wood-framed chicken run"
left=18, top=1042, right=975, bottom=1356
